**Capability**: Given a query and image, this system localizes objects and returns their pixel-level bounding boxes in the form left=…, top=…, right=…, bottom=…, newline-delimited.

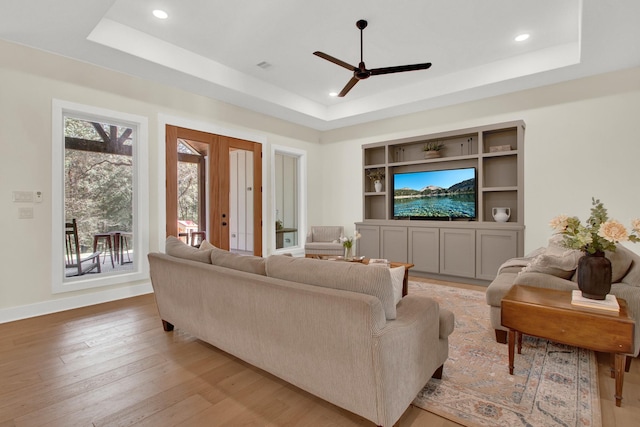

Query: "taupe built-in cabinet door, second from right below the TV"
left=440, top=228, right=476, bottom=278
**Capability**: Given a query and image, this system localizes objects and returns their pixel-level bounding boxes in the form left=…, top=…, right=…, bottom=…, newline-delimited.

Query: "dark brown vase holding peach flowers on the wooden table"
left=578, top=251, right=611, bottom=300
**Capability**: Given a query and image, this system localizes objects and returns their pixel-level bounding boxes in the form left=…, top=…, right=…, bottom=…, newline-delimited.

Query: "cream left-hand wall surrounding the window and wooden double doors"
left=0, top=42, right=323, bottom=322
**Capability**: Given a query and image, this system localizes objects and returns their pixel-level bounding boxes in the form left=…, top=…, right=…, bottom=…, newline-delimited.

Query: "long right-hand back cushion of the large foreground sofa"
left=266, top=255, right=396, bottom=320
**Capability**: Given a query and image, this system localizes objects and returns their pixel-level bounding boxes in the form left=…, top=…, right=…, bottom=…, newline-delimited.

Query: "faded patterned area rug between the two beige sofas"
left=409, top=281, right=602, bottom=427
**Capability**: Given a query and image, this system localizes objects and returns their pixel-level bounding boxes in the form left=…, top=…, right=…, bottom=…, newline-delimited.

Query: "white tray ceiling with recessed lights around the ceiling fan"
left=0, top=0, right=640, bottom=130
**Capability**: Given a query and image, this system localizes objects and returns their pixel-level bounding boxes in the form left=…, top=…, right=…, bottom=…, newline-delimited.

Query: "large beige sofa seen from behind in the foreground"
left=148, top=238, right=454, bottom=426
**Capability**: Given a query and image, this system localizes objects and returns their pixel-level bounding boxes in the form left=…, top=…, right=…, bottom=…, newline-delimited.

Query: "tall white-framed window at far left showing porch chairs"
left=52, top=101, right=149, bottom=293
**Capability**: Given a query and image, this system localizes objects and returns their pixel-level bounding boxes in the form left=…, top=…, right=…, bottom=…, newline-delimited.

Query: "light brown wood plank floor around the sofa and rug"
left=0, top=278, right=640, bottom=427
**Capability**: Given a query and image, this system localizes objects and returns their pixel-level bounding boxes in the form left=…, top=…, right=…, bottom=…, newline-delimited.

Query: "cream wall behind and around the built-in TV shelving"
left=322, top=68, right=640, bottom=253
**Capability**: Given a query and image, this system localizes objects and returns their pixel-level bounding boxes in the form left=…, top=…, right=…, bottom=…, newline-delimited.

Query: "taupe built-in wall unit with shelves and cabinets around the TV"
left=356, top=121, right=525, bottom=281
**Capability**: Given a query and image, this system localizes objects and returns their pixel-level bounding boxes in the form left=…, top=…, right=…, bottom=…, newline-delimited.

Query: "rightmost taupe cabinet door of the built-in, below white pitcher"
left=476, top=230, right=518, bottom=280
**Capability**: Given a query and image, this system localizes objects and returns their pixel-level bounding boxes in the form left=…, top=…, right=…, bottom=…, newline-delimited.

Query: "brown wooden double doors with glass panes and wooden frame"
left=166, top=125, right=262, bottom=256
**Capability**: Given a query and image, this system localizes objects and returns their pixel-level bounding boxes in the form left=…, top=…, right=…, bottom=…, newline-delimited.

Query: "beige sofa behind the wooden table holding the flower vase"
left=486, top=242, right=640, bottom=356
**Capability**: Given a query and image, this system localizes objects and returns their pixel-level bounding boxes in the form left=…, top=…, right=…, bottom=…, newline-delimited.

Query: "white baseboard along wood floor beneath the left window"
left=0, top=282, right=153, bottom=323
